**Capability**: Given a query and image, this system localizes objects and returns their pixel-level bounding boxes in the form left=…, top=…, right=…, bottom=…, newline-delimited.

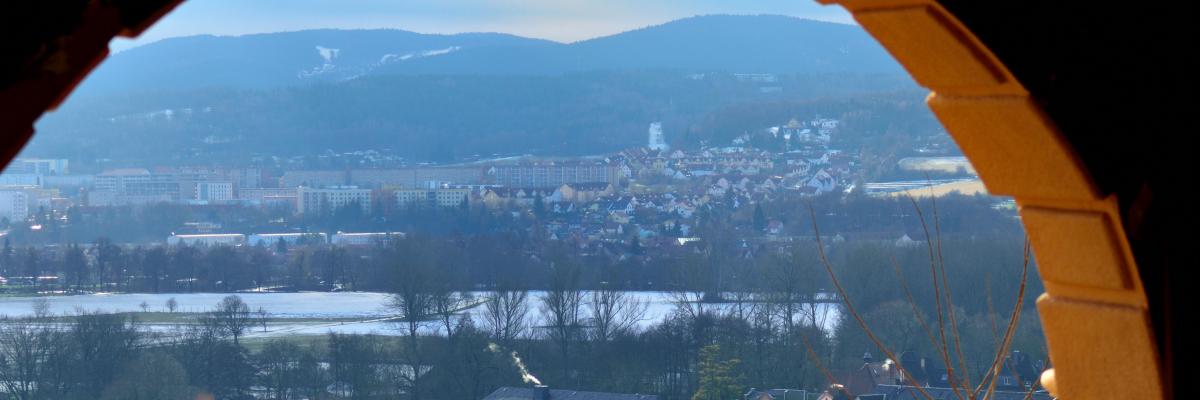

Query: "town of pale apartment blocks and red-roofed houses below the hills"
left=0, top=117, right=984, bottom=246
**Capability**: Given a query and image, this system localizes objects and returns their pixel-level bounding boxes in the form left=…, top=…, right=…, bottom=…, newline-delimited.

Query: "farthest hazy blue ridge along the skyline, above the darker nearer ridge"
left=79, top=16, right=901, bottom=96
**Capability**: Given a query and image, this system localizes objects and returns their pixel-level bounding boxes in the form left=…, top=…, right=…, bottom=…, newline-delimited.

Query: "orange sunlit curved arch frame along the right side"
left=818, top=0, right=1163, bottom=399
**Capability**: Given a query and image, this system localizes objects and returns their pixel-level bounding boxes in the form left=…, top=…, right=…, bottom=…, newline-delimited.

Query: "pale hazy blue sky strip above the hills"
left=112, top=0, right=853, bottom=50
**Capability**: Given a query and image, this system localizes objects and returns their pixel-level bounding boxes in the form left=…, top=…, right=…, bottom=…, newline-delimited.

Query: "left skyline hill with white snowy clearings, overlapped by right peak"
left=77, top=30, right=563, bottom=96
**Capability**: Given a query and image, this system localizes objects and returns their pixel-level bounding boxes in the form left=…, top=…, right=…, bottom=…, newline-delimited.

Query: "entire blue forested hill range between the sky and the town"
left=26, top=16, right=936, bottom=165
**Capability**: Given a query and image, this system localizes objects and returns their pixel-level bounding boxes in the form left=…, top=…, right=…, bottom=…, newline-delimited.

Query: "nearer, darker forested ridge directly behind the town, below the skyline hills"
left=26, top=72, right=932, bottom=163
